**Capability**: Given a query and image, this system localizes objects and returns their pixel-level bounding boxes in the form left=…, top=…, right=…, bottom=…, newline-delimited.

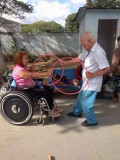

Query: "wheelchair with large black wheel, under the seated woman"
left=0, top=75, right=59, bottom=125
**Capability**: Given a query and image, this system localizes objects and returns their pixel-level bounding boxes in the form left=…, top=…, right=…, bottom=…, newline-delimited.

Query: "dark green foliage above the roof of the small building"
left=84, top=0, right=120, bottom=9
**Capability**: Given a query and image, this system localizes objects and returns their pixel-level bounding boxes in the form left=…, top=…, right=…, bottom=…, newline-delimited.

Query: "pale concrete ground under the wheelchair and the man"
left=0, top=95, right=120, bottom=160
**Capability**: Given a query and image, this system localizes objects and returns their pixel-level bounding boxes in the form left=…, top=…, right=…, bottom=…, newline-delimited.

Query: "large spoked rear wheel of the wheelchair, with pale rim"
left=0, top=91, right=33, bottom=125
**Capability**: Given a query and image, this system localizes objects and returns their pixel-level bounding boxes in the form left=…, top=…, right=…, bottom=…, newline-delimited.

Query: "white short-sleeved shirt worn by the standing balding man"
left=80, top=42, right=109, bottom=92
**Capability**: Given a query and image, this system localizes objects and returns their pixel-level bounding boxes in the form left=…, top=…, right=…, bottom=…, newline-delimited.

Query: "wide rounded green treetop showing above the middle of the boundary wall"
left=21, top=21, right=64, bottom=33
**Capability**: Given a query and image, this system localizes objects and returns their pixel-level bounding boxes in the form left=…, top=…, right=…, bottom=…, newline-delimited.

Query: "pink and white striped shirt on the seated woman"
left=12, top=64, right=35, bottom=86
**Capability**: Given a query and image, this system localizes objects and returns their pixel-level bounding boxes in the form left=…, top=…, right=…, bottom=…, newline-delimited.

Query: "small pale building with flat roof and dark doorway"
left=75, top=8, right=120, bottom=62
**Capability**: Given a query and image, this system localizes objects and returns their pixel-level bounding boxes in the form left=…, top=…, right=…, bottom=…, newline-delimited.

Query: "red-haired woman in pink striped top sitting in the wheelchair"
left=12, top=51, right=62, bottom=117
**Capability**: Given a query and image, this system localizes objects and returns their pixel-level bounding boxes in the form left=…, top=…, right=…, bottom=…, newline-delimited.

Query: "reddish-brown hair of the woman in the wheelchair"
left=13, top=51, right=28, bottom=66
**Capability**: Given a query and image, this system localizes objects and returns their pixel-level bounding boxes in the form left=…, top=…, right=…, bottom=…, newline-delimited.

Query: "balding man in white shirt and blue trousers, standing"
left=68, top=32, right=110, bottom=127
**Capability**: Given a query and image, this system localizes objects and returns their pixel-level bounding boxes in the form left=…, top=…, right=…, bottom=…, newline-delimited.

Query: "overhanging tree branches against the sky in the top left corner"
left=0, top=0, right=33, bottom=19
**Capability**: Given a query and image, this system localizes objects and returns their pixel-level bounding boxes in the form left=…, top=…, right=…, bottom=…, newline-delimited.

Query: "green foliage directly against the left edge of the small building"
left=65, top=13, right=79, bottom=32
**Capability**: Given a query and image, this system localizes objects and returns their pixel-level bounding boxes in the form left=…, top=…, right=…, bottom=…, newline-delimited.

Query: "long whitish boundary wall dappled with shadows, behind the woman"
left=1, top=33, right=79, bottom=56
